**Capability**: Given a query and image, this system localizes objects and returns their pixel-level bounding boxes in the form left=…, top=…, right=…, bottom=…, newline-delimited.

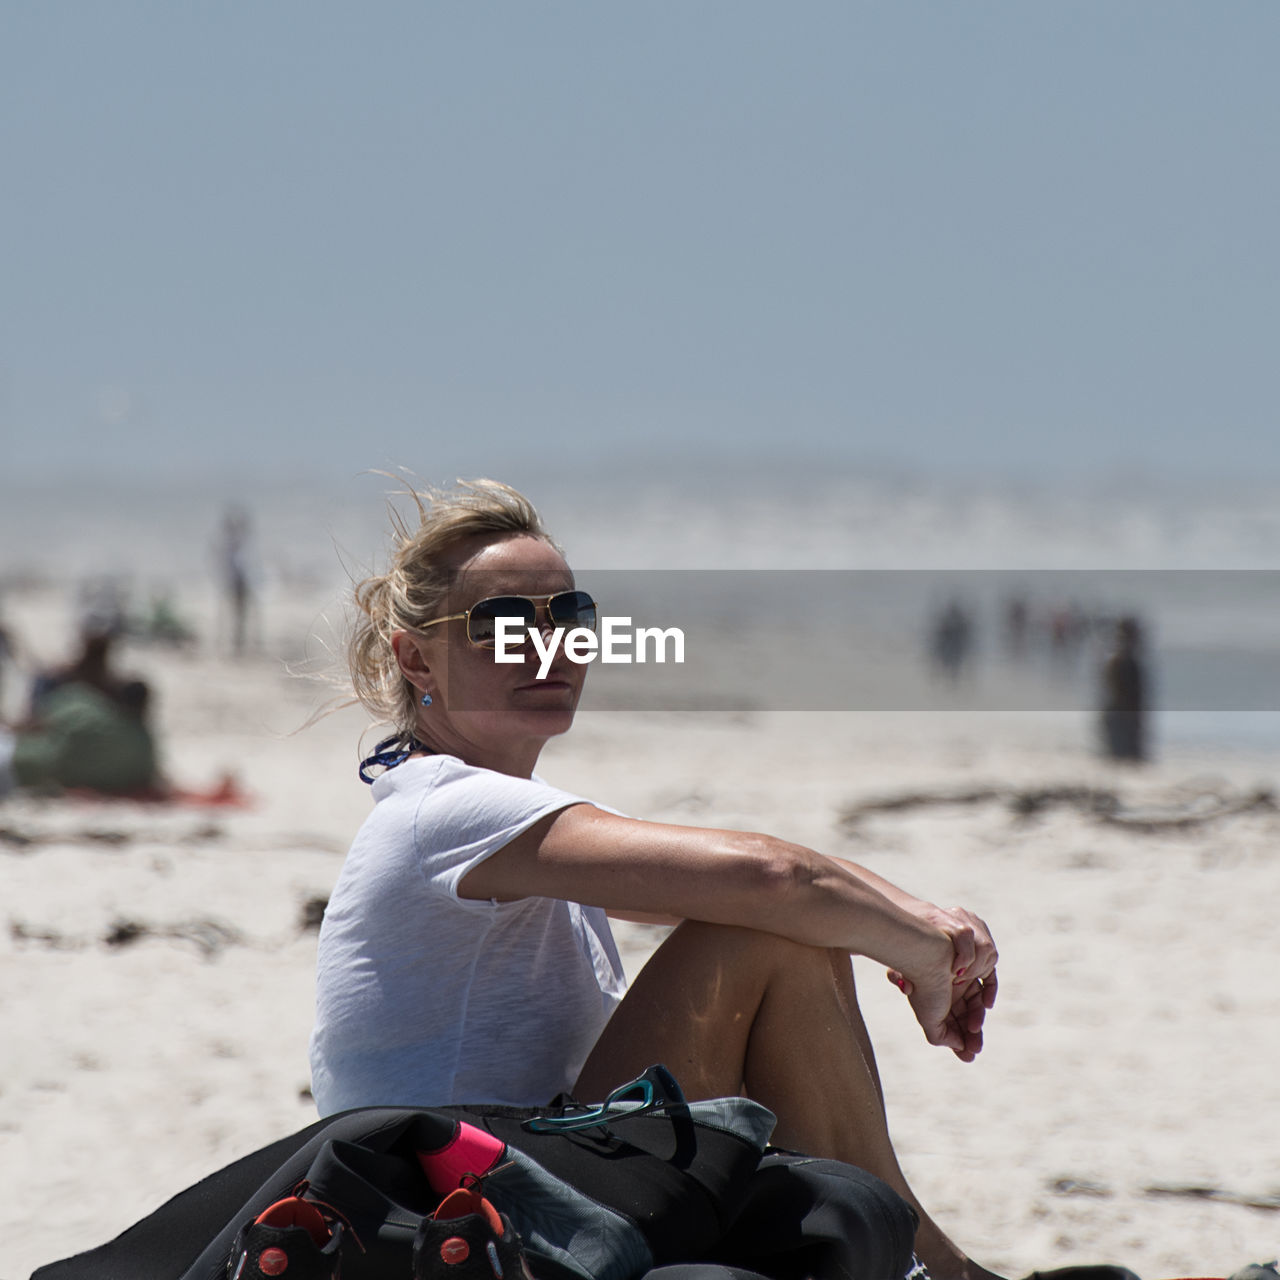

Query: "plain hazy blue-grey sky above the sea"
left=0, top=0, right=1280, bottom=491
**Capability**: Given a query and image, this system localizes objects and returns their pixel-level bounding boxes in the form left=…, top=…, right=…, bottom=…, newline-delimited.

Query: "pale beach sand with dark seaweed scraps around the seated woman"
left=0, top=590, right=1280, bottom=1280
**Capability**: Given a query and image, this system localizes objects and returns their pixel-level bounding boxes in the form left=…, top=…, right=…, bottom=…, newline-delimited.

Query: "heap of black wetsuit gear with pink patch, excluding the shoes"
left=32, top=1068, right=915, bottom=1280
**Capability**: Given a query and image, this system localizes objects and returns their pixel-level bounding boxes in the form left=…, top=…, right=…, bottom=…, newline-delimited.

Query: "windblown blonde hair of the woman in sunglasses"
left=347, top=480, right=559, bottom=740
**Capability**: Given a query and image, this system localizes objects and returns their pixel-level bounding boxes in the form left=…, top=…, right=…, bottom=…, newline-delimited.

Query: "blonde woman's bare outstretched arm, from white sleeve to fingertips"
left=461, top=804, right=997, bottom=1059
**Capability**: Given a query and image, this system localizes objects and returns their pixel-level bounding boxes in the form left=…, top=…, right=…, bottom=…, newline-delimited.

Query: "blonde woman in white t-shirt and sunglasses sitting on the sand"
left=311, top=481, right=996, bottom=1280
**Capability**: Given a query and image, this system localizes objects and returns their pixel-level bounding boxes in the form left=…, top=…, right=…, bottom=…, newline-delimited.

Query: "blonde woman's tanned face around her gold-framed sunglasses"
left=417, top=535, right=586, bottom=759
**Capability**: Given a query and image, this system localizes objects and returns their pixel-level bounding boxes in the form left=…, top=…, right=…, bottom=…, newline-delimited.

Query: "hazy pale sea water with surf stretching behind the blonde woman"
left=0, top=467, right=1280, bottom=748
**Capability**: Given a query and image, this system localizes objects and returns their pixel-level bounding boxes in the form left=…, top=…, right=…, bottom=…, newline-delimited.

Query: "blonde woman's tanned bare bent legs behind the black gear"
left=576, top=922, right=991, bottom=1280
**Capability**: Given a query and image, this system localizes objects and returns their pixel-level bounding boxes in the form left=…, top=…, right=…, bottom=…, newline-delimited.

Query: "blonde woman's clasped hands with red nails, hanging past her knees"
left=888, top=906, right=998, bottom=1062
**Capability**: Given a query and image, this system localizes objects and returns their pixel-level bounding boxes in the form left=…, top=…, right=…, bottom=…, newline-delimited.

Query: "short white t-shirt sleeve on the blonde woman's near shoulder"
left=413, top=765, right=590, bottom=910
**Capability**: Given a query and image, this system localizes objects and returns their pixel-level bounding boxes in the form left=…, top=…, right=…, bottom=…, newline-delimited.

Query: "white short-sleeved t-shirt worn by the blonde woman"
left=311, top=755, right=626, bottom=1116
